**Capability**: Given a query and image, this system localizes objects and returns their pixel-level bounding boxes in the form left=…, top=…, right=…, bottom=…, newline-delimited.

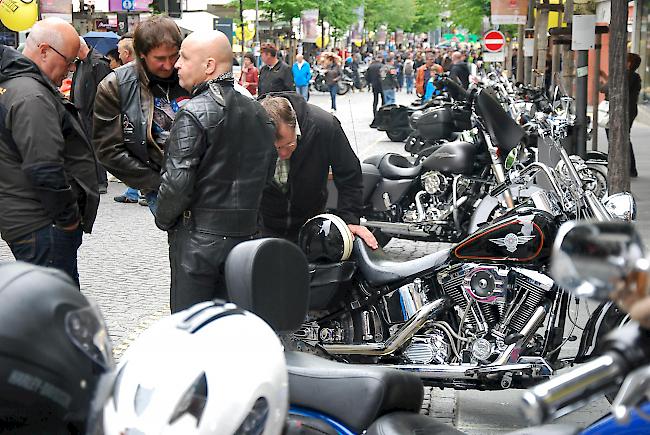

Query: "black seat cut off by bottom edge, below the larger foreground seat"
left=366, top=412, right=463, bottom=435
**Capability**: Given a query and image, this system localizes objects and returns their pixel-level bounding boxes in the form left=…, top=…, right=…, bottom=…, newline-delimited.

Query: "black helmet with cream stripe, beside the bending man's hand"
left=298, top=214, right=354, bottom=263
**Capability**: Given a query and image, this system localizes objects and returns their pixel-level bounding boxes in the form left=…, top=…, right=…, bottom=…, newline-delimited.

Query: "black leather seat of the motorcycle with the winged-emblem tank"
left=352, top=237, right=450, bottom=286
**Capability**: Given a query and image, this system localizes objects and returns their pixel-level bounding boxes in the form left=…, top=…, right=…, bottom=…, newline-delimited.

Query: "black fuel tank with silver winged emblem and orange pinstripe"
left=452, top=208, right=558, bottom=263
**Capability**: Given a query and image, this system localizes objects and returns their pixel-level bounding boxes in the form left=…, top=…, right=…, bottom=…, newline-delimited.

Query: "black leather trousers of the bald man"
left=168, top=223, right=253, bottom=313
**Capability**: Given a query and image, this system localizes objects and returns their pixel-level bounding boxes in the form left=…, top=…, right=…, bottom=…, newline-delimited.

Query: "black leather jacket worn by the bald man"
left=156, top=77, right=276, bottom=237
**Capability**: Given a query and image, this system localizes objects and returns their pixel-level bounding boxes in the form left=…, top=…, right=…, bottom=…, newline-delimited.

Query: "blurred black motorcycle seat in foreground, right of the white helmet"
left=285, top=352, right=424, bottom=433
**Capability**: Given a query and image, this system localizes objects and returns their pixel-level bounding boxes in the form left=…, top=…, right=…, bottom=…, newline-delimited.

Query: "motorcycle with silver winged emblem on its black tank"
left=292, top=101, right=635, bottom=389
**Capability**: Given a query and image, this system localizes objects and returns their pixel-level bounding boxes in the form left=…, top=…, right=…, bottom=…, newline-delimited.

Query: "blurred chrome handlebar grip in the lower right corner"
left=522, top=351, right=627, bottom=425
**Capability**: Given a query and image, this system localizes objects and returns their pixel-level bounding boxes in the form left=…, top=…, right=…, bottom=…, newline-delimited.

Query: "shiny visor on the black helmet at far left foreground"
left=65, top=302, right=115, bottom=370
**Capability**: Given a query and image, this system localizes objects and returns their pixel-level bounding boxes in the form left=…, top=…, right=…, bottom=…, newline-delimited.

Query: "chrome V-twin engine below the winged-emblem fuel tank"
left=404, top=263, right=553, bottom=363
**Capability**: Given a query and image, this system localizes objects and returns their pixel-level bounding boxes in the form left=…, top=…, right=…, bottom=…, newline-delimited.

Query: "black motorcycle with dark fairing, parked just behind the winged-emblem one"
left=362, top=83, right=524, bottom=245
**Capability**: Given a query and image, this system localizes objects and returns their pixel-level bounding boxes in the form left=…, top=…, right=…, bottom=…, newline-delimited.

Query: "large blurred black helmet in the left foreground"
left=0, top=262, right=113, bottom=433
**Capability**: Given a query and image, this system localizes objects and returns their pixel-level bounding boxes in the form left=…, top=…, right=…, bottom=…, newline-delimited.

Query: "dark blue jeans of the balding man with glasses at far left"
left=8, top=225, right=83, bottom=287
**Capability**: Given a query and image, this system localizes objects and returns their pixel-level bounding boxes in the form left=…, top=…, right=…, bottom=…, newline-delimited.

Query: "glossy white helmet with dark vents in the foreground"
left=103, top=301, right=289, bottom=435
